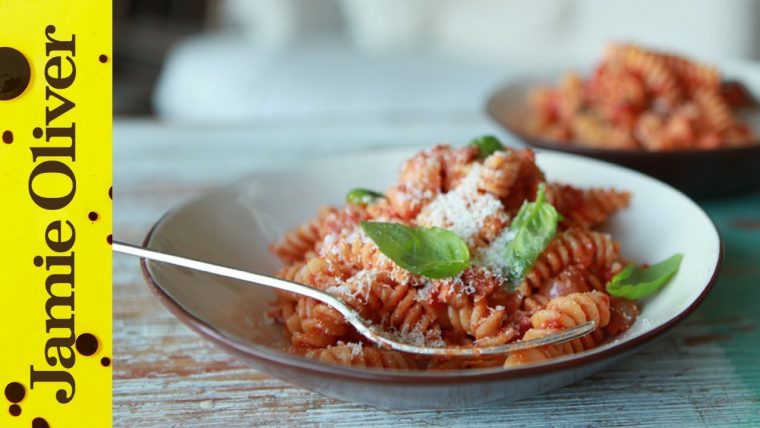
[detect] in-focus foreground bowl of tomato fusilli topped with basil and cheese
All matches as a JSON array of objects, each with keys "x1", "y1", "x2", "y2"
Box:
[{"x1": 142, "y1": 137, "x2": 722, "y2": 409}]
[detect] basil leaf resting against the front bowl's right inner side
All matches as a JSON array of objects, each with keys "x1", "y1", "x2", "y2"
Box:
[{"x1": 607, "y1": 254, "x2": 683, "y2": 300}]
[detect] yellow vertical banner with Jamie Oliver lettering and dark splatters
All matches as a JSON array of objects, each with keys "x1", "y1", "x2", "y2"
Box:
[{"x1": 0, "y1": 0, "x2": 113, "y2": 428}]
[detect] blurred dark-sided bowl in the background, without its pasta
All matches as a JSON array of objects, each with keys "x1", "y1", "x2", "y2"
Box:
[{"x1": 487, "y1": 64, "x2": 760, "y2": 198}]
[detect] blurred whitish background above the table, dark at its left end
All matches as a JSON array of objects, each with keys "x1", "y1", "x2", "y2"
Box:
[{"x1": 115, "y1": 0, "x2": 760, "y2": 120}]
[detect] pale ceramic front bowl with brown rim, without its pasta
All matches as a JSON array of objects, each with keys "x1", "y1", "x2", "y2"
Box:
[{"x1": 143, "y1": 149, "x2": 721, "y2": 409}]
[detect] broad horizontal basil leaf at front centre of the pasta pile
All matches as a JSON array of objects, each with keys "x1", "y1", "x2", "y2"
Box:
[{"x1": 361, "y1": 221, "x2": 470, "y2": 279}]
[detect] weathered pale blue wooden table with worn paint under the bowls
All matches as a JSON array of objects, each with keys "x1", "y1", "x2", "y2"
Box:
[{"x1": 113, "y1": 113, "x2": 760, "y2": 427}]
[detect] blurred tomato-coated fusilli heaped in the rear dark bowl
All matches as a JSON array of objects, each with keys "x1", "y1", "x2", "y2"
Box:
[{"x1": 524, "y1": 44, "x2": 757, "y2": 151}]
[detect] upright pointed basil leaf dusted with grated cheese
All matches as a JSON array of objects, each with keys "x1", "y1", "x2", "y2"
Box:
[{"x1": 505, "y1": 184, "x2": 561, "y2": 286}]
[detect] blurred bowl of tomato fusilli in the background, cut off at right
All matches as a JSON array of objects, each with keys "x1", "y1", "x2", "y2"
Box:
[{"x1": 487, "y1": 44, "x2": 760, "y2": 198}]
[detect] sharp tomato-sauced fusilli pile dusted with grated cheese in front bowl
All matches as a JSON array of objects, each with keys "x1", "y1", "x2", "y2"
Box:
[{"x1": 270, "y1": 143, "x2": 638, "y2": 370}]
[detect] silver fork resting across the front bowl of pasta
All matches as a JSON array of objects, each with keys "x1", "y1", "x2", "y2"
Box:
[{"x1": 113, "y1": 241, "x2": 596, "y2": 357}]
